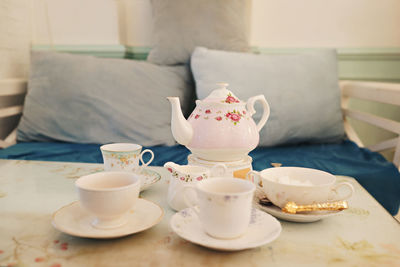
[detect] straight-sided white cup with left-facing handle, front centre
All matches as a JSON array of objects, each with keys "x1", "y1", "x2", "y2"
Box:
[{"x1": 184, "y1": 177, "x2": 256, "y2": 239}]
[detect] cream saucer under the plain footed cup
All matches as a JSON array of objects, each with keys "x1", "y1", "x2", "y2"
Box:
[{"x1": 52, "y1": 198, "x2": 164, "y2": 239}]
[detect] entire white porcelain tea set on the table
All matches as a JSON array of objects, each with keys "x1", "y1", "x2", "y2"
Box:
[{"x1": 52, "y1": 83, "x2": 354, "y2": 251}]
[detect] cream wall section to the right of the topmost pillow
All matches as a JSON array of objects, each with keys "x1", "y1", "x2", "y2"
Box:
[{"x1": 251, "y1": 0, "x2": 400, "y2": 47}]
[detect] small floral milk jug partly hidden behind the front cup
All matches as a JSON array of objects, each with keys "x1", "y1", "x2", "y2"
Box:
[{"x1": 164, "y1": 162, "x2": 228, "y2": 211}]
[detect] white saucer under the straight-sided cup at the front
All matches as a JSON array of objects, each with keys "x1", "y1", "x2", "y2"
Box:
[{"x1": 170, "y1": 208, "x2": 282, "y2": 251}]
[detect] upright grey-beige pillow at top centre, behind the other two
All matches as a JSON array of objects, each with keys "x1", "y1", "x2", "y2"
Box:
[{"x1": 148, "y1": 0, "x2": 251, "y2": 65}]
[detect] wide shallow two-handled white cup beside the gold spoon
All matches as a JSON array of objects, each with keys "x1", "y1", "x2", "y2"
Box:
[{"x1": 247, "y1": 167, "x2": 354, "y2": 208}]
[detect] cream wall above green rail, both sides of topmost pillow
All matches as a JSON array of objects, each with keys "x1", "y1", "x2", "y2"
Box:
[{"x1": 32, "y1": 0, "x2": 400, "y2": 47}]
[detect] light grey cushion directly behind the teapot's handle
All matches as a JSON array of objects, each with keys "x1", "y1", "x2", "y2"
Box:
[{"x1": 191, "y1": 47, "x2": 344, "y2": 146}]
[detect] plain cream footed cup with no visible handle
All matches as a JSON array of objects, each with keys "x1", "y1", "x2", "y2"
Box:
[{"x1": 75, "y1": 172, "x2": 140, "y2": 229}]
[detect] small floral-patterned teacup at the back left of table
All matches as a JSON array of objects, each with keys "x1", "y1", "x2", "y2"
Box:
[{"x1": 100, "y1": 143, "x2": 154, "y2": 172}]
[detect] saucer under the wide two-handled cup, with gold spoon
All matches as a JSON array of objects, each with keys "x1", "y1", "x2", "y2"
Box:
[{"x1": 254, "y1": 194, "x2": 341, "y2": 222}]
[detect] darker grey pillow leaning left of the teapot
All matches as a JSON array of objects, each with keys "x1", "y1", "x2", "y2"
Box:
[{"x1": 18, "y1": 52, "x2": 194, "y2": 146}]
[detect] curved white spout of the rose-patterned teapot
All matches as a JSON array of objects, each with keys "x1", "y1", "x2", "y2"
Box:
[{"x1": 167, "y1": 97, "x2": 193, "y2": 146}]
